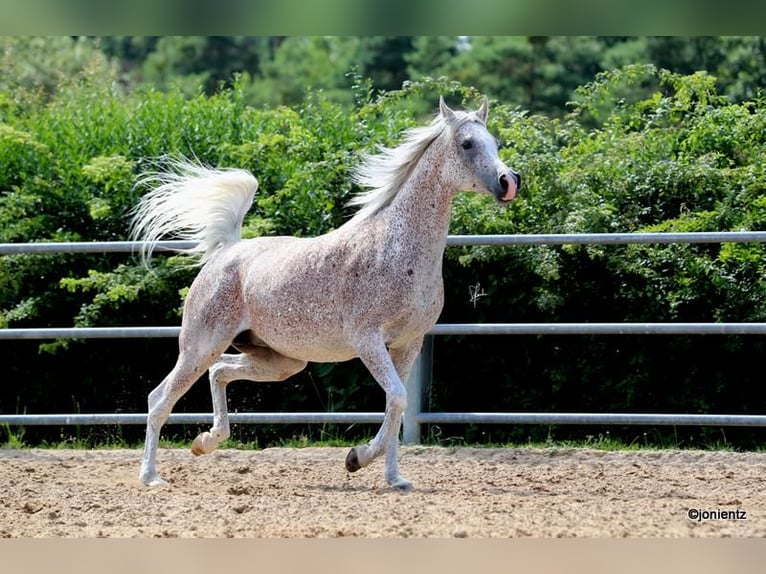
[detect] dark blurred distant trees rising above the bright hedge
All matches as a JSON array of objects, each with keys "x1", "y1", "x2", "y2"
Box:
[{"x1": 90, "y1": 36, "x2": 766, "y2": 117}]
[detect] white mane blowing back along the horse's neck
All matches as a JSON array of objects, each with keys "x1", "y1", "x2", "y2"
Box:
[{"x1": 348, "y1": 112, "x2": 476, "y2": 219}]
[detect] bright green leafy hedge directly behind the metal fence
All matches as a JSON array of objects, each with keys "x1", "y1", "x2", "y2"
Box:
[{"x1": 0, "y1": 44, "x2": 766, "y2": 450}]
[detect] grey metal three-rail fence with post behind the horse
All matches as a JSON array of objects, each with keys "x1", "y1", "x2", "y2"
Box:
[{"x1": 0, "y1": 231, "x2": 766, "y2": 443}]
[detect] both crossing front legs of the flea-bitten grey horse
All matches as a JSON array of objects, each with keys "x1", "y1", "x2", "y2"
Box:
[{"x1": 346, "y1": 337, "x2": 423, "y2": 490}]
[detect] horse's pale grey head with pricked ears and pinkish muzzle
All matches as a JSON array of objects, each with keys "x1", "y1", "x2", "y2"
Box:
[{"x1": 439, "y1": 97, "x2": 521, "y2": 203}]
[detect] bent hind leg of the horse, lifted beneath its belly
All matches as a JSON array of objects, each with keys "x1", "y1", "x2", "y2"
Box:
[{"x1": 191, "y1": 347, "x2": 306, "y2": 455}]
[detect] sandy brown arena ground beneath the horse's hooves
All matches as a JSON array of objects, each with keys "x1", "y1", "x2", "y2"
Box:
[{"x1": 0, "y1": 446, "x2": 766, "y2": 538}]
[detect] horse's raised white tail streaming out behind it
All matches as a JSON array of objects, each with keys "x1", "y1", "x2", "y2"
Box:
[{"x1": 131, "y1": 160, "x2": 258, "y2": 265}]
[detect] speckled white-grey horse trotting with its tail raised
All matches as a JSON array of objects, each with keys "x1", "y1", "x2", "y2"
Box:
[{"x1": 132, "y1": 98, "x2": 521, "y2": 489}]
